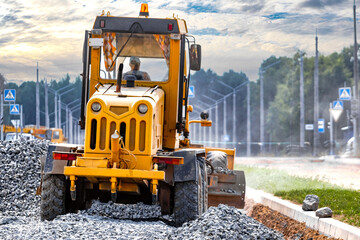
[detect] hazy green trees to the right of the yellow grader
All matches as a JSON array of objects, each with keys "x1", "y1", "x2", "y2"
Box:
[{"x1": 190, "y1": 47, "x2": 354, "y2": 156}]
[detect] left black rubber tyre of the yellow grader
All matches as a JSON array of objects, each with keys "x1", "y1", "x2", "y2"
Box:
[{"x1": 40, "y1": 174, "x2": 66, "y2": 221}]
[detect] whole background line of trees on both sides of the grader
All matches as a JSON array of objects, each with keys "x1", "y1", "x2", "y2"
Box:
[{"x1": 0, "y1": 47, "x2": 354, "y2": 155}]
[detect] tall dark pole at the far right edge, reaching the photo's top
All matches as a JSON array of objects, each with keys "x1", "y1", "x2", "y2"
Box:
[{"x1": 353, "y1": 0, "x2": 359, "y2": 156}]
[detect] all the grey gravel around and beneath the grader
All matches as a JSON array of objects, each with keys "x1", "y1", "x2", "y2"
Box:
[{"x1": 0, "y1": 140, "x2": 283, "y2": 240}]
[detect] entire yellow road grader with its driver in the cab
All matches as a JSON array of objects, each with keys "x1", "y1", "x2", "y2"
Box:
[{"x1": 39, "y1": 4, "x2": 245, "y2": 225}]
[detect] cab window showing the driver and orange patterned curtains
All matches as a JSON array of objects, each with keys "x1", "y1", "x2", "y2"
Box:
[{"x1": 100, "y1": 32, "x2": 170, "y2": 81}]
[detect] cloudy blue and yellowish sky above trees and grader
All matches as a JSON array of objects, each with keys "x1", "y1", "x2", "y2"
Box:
[{"x1": 0, "y1": 0, "x2": 360, "y2": 84}]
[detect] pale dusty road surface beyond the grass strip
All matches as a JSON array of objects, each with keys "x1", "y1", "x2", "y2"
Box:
[{"x1": 235, "y1": 156, "x2": 360, "y2": 190}]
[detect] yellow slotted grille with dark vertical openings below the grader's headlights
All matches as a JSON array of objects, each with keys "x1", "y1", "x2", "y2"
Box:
[{"x1": 89, "y1": 117, "x2": 146, "y2": 152}]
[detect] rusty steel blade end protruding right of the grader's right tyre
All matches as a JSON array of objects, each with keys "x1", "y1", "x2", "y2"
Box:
[{"x1": 208, "y1": 171, "x2": 246, "y2": 208}]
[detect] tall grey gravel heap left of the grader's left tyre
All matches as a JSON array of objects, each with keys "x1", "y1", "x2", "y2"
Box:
[{"x1": 0, "y1": 137, "x2": 48, "y2": 216}]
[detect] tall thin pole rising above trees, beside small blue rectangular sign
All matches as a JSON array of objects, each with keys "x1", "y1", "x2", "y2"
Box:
[{"x1": 313, "y1": 31, "x2": 319, "y2": 156}]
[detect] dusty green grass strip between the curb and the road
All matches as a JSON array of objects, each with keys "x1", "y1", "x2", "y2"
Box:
[{"x1": 235, "y1": 165, "x2": 360, "y2": 227}]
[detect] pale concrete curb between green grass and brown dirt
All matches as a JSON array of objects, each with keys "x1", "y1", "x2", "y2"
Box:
[{"x1": 246, "y1": 187, "x2": 360, "y2": 240}]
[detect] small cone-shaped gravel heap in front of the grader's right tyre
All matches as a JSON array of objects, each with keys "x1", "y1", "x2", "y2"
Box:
[{"x1": 167, "y1": 204, "x2": 284, "y2": 240}]
